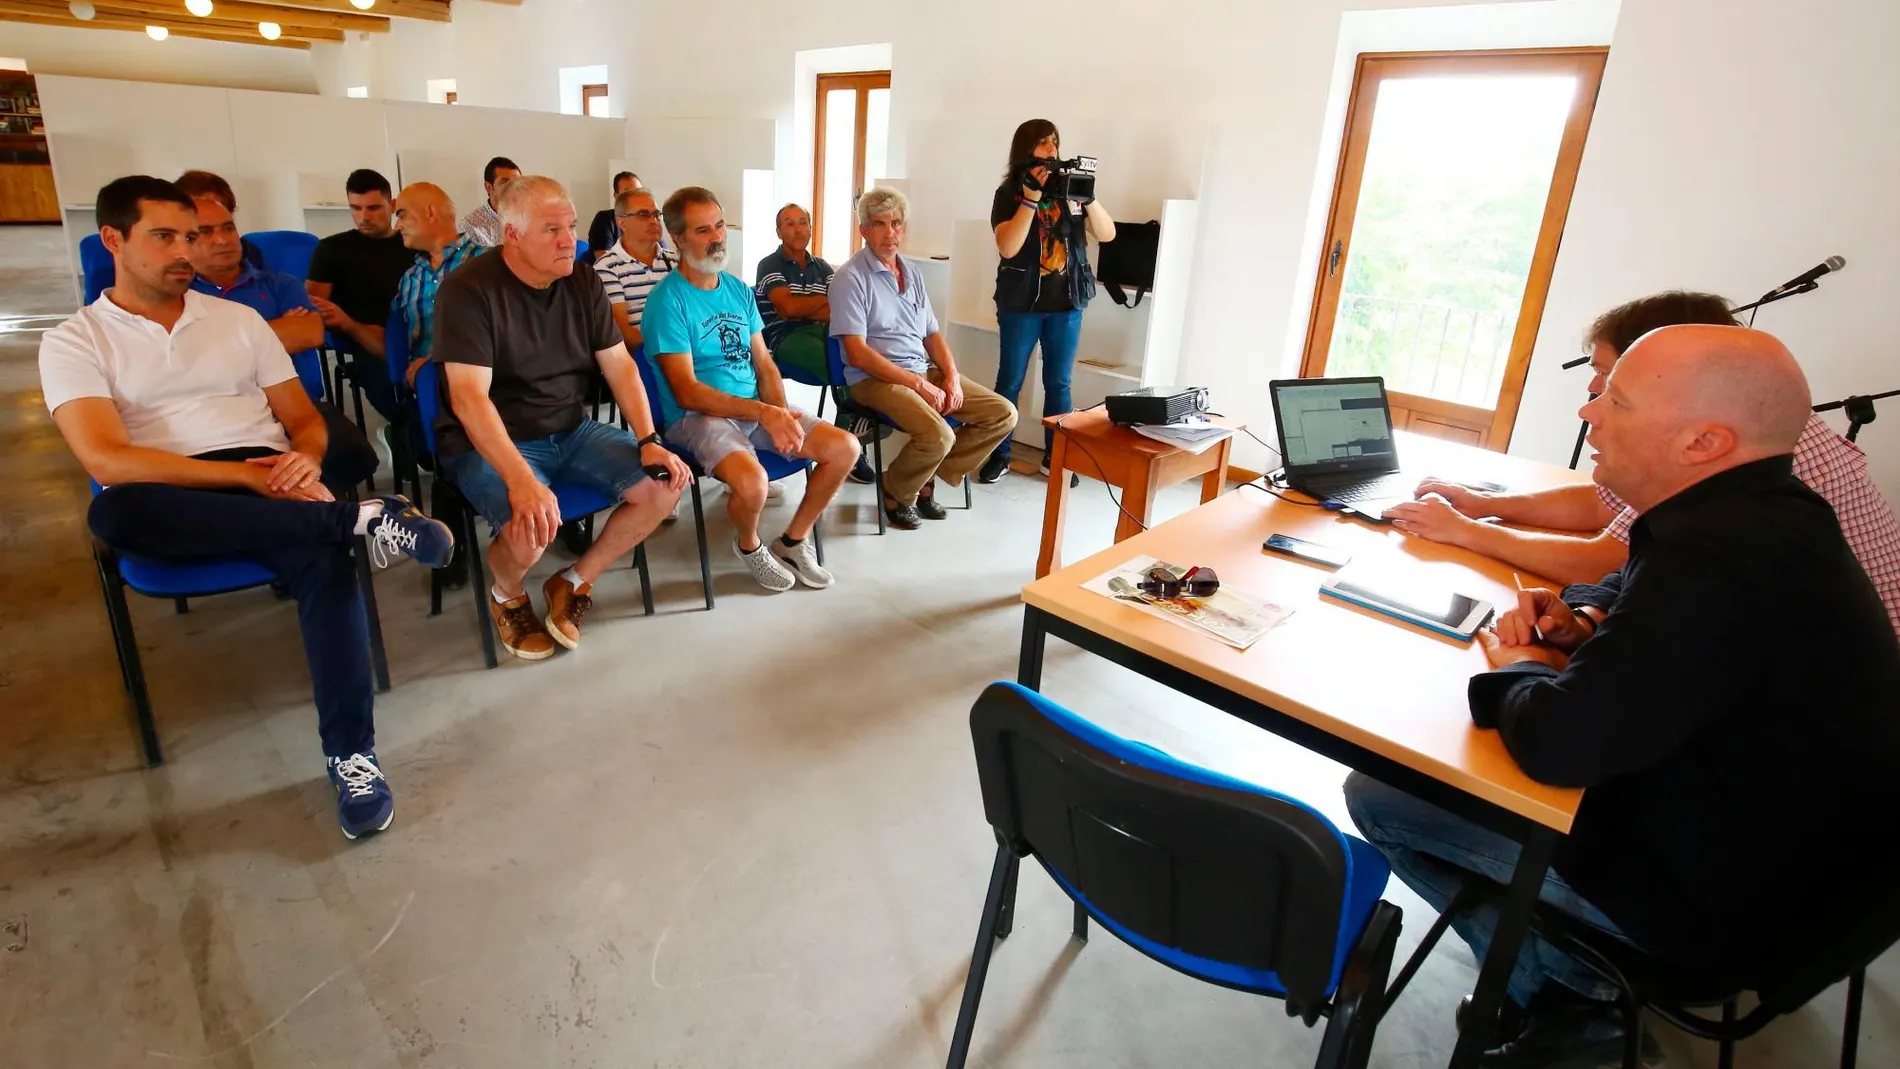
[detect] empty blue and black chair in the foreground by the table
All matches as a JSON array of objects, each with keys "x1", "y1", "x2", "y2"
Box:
[{"x1": 948, "y1": 684, "x2": 1400, "y2": 1069}]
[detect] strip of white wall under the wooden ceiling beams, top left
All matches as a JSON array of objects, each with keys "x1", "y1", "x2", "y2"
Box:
[{"x1": 0, "y1": 21, "x2": 315, "y2": 95}]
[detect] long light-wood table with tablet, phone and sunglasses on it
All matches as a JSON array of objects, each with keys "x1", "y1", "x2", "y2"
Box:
[{"x1": 1018, "y1": 435, "x2": 1583, "y2": 1067}]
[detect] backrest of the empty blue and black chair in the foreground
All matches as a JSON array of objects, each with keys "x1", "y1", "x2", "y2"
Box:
[{"x1": 969, "y1": 684, "x2": 1353, "y2": 1018}]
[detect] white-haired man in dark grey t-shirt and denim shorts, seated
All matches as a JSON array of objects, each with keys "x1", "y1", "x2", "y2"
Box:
[{"x1": 433, "y1": 175, "x2": 692, "y2": 661}]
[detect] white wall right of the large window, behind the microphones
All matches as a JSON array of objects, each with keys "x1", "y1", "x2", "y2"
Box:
[{"x1": 1511, "y1": 0, "x2": 1900, "y2": 501}]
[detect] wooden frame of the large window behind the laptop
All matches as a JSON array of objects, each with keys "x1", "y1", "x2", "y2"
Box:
[{"x1": 1300, "y1": 47, "x2": 1609, "y2": 450}]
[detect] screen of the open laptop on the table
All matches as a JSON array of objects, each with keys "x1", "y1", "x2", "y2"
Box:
[{"x1": 1271, "y1": 378, "x2": 1398, "y2": 475}]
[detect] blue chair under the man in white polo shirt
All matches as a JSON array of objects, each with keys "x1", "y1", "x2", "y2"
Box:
[{"x1": 91, "y1": 482, "x2": 390, "y2": 767}]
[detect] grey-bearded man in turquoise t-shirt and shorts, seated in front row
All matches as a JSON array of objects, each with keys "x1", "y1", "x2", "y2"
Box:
[{"x1": 640, "y1": 186, "x2": 859, "y2": 591}]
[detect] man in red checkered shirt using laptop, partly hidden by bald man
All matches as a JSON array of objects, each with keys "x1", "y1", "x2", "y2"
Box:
[{"x1": 1385, "y1": 291, "x2": 1900, "y2": 632}]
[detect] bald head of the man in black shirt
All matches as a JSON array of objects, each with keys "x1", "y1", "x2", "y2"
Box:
[{"x1": 1583, "y1": 325, "x2": 1809, "y2": 511}]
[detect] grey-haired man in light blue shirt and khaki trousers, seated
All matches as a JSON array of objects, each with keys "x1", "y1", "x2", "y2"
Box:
[{"x1": 828, "y1": 190, "x2": 1017, "y2": 530}]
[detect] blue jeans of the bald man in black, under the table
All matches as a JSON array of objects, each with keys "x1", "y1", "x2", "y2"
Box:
[{"x1": 1345, "y1": 773, "x2": 1623, "y2": 1006}]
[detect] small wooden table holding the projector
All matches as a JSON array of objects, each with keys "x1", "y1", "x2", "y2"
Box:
[{"x1": 1036, "y1": 408, "x2": 1246, "y2": 579}]
